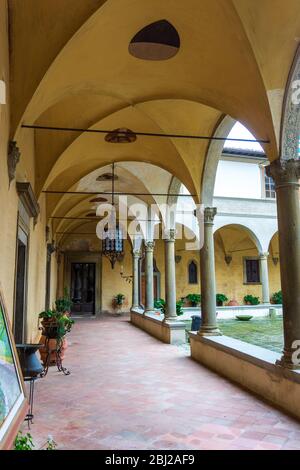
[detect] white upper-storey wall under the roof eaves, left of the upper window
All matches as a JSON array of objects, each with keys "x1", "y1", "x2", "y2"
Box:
[{"x1": 214, "y1": 160, "x2": 262, "y2": 199}]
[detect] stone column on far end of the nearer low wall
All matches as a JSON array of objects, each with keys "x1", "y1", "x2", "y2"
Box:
[{"x1": 198, "y1": 207, "x2": 221, "y2": 336}]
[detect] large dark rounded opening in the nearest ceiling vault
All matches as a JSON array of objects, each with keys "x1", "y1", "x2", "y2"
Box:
[{"x1": 129, "y1": 20, "x2": 180, "y2": 60}]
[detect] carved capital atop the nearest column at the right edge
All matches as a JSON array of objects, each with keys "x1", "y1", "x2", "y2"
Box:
[{"x1": 266, "y1": 159, "x2": 300, "y2": 189}]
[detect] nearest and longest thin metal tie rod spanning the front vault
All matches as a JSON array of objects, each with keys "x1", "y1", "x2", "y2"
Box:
[{"x1": 21, "y1": 124, "x2": 270, "y2": 144}]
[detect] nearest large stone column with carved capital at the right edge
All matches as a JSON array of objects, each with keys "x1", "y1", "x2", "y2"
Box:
[{"x1": 267, "y1": 160, "x2": 300, "y2": 369}]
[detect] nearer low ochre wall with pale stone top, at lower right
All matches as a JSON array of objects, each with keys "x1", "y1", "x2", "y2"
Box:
[{"x1": 190, "y1": 333, "x2": 300, "y2": 419}]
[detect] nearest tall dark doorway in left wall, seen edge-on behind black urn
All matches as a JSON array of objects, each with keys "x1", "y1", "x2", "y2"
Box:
[{"x1": 14, "y1": 227, "x2": 28, "y2": 343}]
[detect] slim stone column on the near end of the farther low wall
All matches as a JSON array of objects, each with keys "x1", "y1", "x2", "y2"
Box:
[{"x1": 165, "y1": 229, "x2": 177, "y2": 321}]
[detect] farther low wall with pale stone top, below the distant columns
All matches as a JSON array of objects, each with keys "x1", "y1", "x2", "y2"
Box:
[{"x1": 130, "y1": 309, "x2": 186, "y2": 344}]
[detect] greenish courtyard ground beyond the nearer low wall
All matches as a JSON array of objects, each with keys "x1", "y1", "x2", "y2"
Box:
[{"x1": 187, "y1": 316, "x2": 283, "y2": 352}]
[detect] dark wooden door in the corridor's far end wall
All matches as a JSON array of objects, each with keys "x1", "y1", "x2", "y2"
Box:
[{"x1": 71, "y1": 263, "x2": 96, "y2": 315}]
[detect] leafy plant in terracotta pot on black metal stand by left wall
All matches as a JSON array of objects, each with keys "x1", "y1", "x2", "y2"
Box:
[{"x1": 39, "y1": 310, "x2": 74, "y2": 366}]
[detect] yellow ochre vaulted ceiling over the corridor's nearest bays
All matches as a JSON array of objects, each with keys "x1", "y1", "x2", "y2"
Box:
[{"x1": 9, "y1": 0, "x2": 300, "y2": 226}]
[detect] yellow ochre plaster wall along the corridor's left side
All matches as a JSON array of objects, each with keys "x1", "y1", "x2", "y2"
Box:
[{"x1": 0, "y1": 0, "x2": 57, "y2": 342}]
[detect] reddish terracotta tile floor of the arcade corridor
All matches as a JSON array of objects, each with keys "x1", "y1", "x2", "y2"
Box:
[{"x1": 24, "y1": 317, "x2": 300, "y2": 450}]
